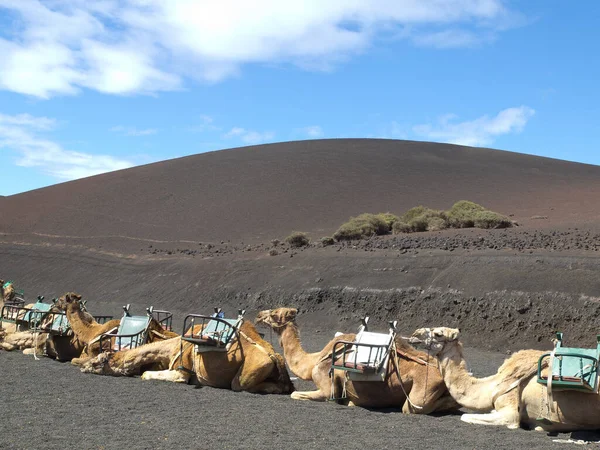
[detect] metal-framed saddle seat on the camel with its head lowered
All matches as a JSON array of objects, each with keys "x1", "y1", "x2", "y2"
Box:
[{"x1": 181, "y1": 308, "x2": 246, "y2": 352}]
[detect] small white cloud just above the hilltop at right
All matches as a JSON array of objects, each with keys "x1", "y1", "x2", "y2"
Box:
[{"x1": 413, "y1": 106, "x2": 535, "y2": 146}]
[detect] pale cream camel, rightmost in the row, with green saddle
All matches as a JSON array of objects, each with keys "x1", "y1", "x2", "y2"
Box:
[{"x1": 411, "y1": 327, "x2": 600, "y2": 432}]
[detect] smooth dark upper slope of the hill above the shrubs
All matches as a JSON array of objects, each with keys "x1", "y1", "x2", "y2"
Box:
[{"x1": 0, "y1": 139, "x2": 600, "y2": 241}]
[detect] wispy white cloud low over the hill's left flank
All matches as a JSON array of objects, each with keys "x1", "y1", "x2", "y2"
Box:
[{"x1": 0, "y1": 114, "x2": 133, "y2": 180}]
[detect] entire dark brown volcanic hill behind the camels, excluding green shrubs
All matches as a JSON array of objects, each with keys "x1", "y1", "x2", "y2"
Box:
[{"x1": 0, "y1": 139, "x2": 600, "y2": 349}]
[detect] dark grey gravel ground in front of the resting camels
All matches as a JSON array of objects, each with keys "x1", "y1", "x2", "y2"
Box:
[{"x1": 0, "y1": 336, "x2": 596, "y2": 450}]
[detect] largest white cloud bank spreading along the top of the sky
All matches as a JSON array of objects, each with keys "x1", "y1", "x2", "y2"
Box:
[{"x1": 0, "y1": 0, "x2": 516, "y2": 98}]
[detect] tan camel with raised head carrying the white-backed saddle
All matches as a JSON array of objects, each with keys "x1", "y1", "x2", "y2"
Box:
[{"x1": 256, "y1": 308, "x2": 458, "y2": 414}]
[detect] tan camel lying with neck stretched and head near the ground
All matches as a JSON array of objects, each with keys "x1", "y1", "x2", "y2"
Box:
[{"x1": 82, "y1": 322, "x2": 294, "y2": 394}]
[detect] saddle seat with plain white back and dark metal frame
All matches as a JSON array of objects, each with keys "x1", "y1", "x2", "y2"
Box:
[{"x1": 329, "y1": 317, "x2": 398, "y2": 400}]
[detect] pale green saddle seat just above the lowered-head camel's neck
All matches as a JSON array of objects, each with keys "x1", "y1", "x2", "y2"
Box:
[{"x1": 100, "y1": 304, "x2": 153, "y2": 352}]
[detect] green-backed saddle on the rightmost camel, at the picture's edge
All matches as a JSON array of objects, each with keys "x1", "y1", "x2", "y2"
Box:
[{"x1": 537, "y1": 332, "x2": 600, "y2": 394}]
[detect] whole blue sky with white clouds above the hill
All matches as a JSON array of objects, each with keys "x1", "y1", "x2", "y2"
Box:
[{"x1": 0, "y1": 0, "x2": 600, "y2": 195}]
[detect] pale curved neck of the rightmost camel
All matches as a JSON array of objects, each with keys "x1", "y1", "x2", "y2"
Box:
[{"x1": 438, "y1": 341, "x2": 496, "y2": 411}]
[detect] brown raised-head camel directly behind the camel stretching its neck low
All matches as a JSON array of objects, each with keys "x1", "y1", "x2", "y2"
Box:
[{"x1": 56, "y1": 292, "x2": 178, "y2": 365}]
